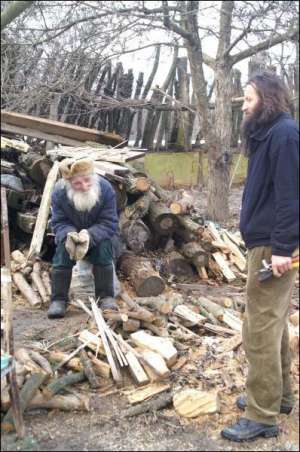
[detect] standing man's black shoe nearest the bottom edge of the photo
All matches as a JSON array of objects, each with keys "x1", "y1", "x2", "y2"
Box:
[{"x1": 221, "y1": 417, "x2": 279, "y2": 442}]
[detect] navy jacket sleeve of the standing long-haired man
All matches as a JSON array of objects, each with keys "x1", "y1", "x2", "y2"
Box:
[{"x1": 271, "y1": 137, "x2": 299, "y2": 256}]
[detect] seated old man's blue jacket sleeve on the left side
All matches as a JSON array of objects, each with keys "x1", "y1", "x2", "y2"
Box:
[{"x1": 51, "y1": 191, "x2": 77, "y2": 243}]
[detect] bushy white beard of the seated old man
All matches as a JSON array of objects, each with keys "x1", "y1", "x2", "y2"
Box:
[{"x1": 65, "y1": 176, "x2": 101, "y2": 212}]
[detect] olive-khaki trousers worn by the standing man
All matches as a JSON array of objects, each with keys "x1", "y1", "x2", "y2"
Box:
[{"x1": 243, "y1": 246, "x2": 296, "y2": 425}]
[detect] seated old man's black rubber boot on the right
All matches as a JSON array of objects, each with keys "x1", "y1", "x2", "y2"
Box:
[{"x1": 93, "y1": 265, "x2": 118, "y2": 311}]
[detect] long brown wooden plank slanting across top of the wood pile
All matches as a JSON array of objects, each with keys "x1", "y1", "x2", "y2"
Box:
[{"x1": 1, "y1": 110, "x2": 123, "y2": 145}]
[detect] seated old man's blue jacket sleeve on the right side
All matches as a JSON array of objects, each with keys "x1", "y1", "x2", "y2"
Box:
[{"x1": 88, "y1": 183, "x2": 119, "y2": 247}]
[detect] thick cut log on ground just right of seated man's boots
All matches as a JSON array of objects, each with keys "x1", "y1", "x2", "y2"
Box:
[{"x1": 120, "y1": 255, "x2": 165, "y2": 297}]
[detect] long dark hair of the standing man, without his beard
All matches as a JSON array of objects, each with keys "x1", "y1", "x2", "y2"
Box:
[{"x1": 247, "y1": 72, "x2": 294, "y2": 124}]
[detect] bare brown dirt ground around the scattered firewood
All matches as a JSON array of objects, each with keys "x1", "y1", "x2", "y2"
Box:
[{"x1": 1, "y1": 188, "x2": 299, "y2": 451}]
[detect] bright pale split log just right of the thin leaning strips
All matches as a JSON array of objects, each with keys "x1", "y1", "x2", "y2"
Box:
[{"x1": 130, "y1": 330, "x2": 177, "y2": 366}]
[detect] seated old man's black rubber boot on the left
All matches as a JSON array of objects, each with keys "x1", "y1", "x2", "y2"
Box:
[{"x1": 48, "y1": 267, "x2": 72, "y2": 319}]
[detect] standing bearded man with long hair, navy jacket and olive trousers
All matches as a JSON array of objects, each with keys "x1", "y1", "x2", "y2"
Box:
[{"x1": 222, "y1": 72, "x2": 299, "y2": 441}]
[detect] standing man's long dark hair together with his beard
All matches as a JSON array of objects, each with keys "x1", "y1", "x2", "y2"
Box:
[{"x1": 241, "y1": 72, "x2": 294, "y2": 156}]
